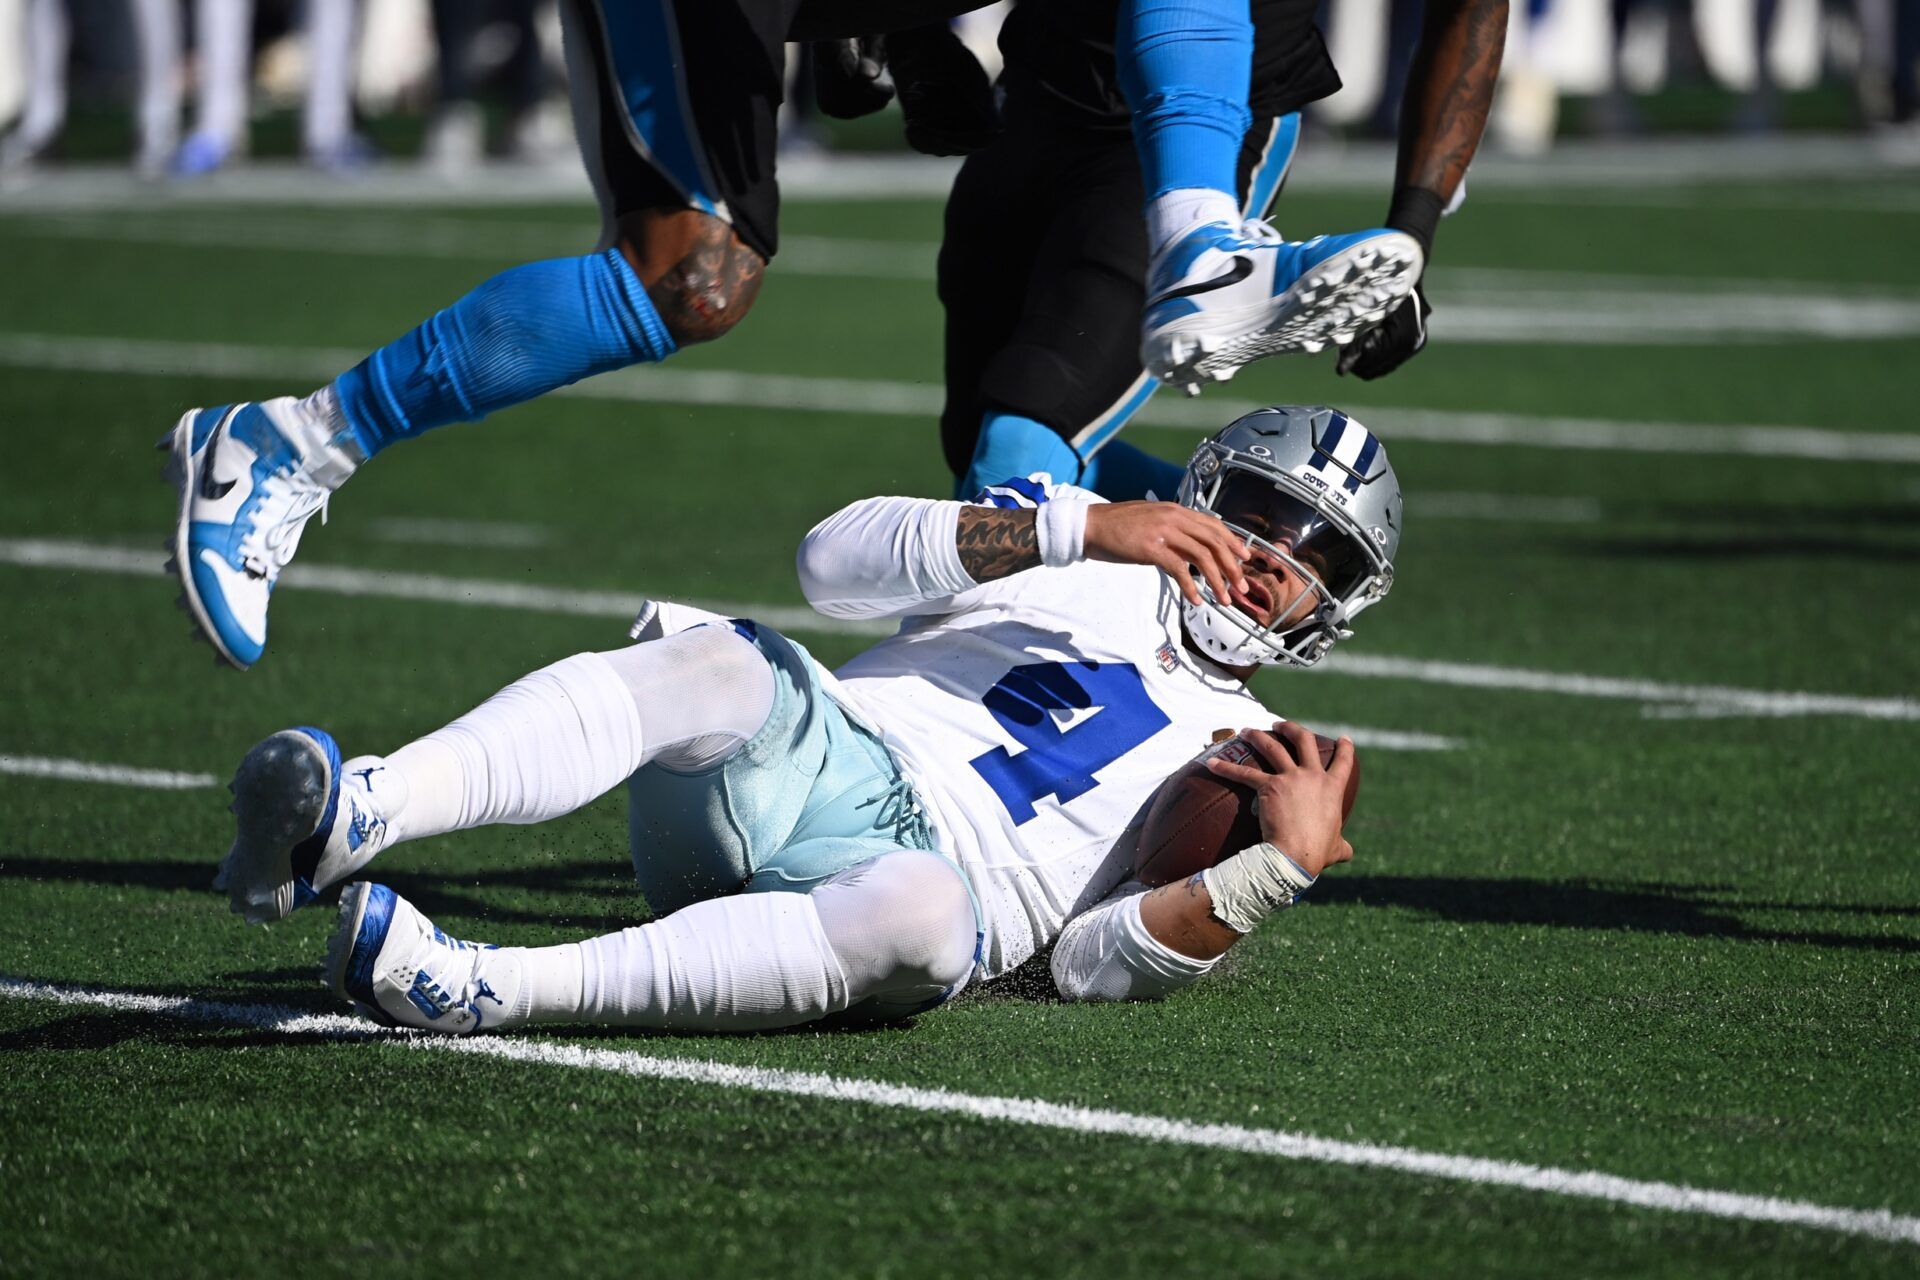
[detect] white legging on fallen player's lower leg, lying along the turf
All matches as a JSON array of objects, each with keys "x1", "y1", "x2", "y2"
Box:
[{"x1": 513, "y1": 850, "x2": 977, "y2": 1031}]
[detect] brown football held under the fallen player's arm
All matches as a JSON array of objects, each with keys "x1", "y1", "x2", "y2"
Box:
[{"x1": 1133, "y1": 733, "x2": 1359, "y2": 885}]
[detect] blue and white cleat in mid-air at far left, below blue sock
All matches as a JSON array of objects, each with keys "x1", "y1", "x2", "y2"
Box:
[{"x1": 157, "y1": 397, "x2": 332, "y2": 670}]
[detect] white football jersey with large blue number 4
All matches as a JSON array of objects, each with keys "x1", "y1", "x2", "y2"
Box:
[{"x1": 810, "y1": 476, "x2": 1275, "y2": 979}]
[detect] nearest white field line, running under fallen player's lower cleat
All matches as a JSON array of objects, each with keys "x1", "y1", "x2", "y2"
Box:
[{"x1": 0, "y1": 979, "x2": 1920, "y2": 1244}]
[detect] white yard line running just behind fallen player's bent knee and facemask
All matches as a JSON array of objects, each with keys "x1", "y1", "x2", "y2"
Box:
[{"x1": 0, "y1": 537, "x2": 1920, "y2": 725}]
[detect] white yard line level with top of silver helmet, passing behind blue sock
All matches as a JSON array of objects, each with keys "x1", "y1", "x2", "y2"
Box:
[{"x1": 0, "y1": 332, "x2": 1920, "y2": 462}]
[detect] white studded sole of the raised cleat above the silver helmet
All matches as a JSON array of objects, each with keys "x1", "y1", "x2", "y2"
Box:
[{"x1": 1142, "y1": 232, "x2": 1423, "y2": 395}]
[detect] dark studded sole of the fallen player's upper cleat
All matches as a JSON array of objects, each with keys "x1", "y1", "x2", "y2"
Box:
[{"x1": 221, "y1": 729, "x2": 334, "y2": 925}]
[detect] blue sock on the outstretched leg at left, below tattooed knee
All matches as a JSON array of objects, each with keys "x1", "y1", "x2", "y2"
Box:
[{"x1": 334, "y1": 249, "x2": 676, "y2": 459}]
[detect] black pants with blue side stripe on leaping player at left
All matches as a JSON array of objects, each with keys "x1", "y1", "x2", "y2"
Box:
[{"x1": 561, "y1": 0, "x2": 983, "y2": 257}]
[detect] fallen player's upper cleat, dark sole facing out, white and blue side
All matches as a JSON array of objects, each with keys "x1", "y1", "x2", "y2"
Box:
[{"x1": 213, "y1": 725, "x2": 405, "y2": 925}]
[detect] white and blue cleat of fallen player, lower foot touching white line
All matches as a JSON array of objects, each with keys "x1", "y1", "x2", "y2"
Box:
[{"x1": 324, "y1": 883, "x2": 524, "y2": 1036}]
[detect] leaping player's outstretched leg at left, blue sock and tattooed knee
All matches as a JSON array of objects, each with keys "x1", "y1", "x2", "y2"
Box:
[{"x1": 161, "y1": 0, "x2": 778, "y2": 668}]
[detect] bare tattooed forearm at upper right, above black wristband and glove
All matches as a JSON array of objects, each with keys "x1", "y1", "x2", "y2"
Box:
[{"x1": 1396, "y1": 0, "x2": 1507, "y2": 200}]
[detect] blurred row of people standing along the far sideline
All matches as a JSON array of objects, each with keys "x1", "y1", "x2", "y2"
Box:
[{"x1": 0, "y1": 0, "x2": 1920, "y2": 180}]
